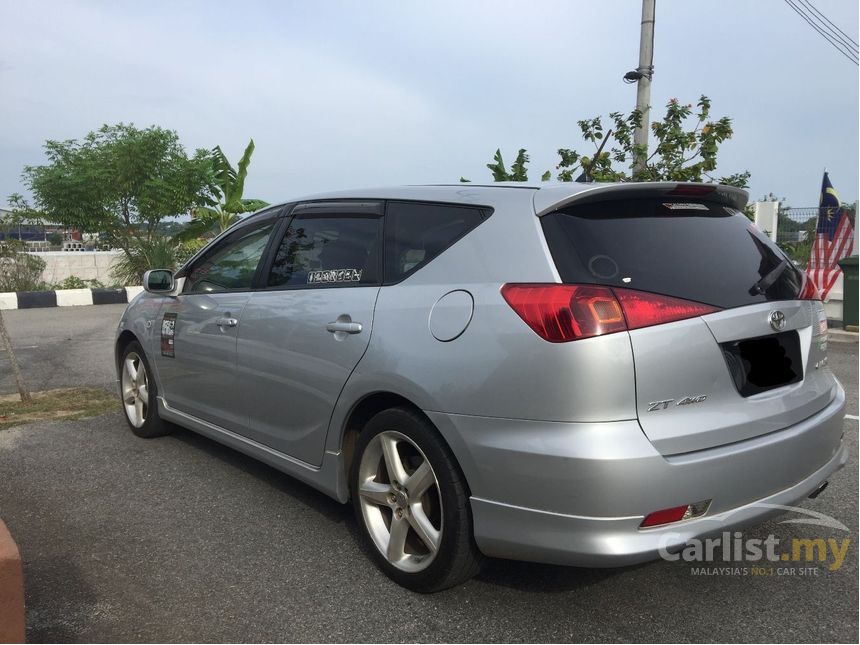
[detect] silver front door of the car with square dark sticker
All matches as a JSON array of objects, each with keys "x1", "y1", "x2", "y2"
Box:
[{"x1": 156, "y1": 210, "x2": 278, "y2": 432}]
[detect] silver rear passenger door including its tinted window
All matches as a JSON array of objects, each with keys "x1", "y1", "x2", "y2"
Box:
[{"x1": 238, "y1": 202, "x2": 382, "y2": 465}]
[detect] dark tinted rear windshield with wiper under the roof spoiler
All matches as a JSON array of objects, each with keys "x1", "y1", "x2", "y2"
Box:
[{"x1": 542, "y1": 199, "x2": 803, "y2": 308}]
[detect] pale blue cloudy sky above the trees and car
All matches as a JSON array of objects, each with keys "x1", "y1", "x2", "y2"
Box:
[{"x1": 0, "y1": 0, "x2": 858, "y2": 207}]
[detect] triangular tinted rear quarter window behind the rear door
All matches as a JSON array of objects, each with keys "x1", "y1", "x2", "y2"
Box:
[{"x1": 385, "y1": 202, "x2": 486, "y2": 282}]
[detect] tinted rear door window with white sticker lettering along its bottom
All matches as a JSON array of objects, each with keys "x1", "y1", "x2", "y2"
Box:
[{"x1": 266, "y1": 215, "x2": 381, "y2": 287}]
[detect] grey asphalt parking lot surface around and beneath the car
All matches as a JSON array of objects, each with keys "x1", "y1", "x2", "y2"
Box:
[{"x1": 0, "y1": 306, "x2": 858, "y2": 642}]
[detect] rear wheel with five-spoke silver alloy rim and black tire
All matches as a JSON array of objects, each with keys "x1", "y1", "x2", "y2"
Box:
[{"x1": 350, "y1": 408, "x2": 481, "y2": 593}]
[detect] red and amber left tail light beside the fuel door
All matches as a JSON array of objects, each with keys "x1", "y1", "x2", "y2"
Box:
[{"x1": 502, "y1": 284, "x2": 718, "y2": 343}]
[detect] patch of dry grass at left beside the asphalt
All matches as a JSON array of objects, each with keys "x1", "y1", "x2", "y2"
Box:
[{"x1": 0, "y1": 387, "x2": 119, "y2": 430}]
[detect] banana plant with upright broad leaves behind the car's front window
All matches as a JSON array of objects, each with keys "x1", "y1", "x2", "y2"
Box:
[{"x1": 179, "y1": 139, "x2": 268, "y2": 240}]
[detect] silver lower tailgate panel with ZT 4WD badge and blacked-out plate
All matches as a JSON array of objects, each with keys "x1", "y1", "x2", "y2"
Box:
[{"x1": 630, "y1": 301, "x2": 835, "y2": 454}]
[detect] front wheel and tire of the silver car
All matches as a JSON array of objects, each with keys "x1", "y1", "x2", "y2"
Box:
[{"x1": 119, "y1": 341, "x2": 170, "y2": 439}]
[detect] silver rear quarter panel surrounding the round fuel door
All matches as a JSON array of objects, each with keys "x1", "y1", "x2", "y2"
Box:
[{"x1": 327, "y1": 197, "x2": 636, "y2": 450}]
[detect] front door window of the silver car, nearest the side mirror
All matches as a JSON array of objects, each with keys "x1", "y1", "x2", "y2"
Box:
[{"x1": 182, "y1": 219, "x2": 276, "y2": 293}]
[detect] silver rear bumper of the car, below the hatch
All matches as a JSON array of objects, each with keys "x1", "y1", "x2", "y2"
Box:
[{"x1": 428, "y1": 387, "x2": 848, "y2": 566}]
